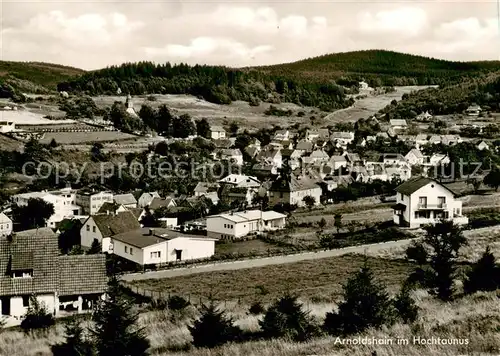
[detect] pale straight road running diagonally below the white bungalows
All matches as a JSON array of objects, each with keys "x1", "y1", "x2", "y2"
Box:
[{"x1": 122, "y1": 239, "x2": 412, "y2": 282}]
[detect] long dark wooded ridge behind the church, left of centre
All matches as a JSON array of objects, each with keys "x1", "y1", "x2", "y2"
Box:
[{"x1": 58, "y1": 62, "x2": 352, "y2": 111}]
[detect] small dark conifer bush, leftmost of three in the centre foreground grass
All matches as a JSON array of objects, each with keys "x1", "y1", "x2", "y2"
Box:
[{"x1": 188, "y1": 302, "x2": 242, "y2": 348}]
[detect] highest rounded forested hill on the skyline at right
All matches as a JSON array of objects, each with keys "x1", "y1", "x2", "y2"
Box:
[{"x1": 256, "y1": 50, "x2": 500, "y2": 86}]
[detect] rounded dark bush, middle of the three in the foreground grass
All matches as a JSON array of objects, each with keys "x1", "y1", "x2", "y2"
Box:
[{"x1": 259, "y1": 295, "x2": 318, "y2": 341}]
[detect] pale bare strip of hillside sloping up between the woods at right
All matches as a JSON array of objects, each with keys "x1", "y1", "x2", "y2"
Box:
[{"x1": 323, "y1": 86, "x2": 428, "y2": 124}]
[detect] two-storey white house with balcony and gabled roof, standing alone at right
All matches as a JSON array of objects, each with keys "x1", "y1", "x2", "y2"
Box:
[{"x1": 393, "y1": 177, "x2": 469, "y2": 228}]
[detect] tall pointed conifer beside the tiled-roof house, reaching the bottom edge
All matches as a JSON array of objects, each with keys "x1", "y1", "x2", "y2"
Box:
[{"x1": 91, "y1": 276, "x2": 149, "y2": 356}]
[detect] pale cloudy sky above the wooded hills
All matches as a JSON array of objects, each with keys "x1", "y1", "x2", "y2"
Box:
[{"x1": 0, "y1": 0, "x2": 500, "y2": 70}]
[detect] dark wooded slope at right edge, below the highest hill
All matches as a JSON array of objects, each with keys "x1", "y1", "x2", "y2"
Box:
[{"x1": 381, "y1": 72, "x2": 500, "y2": 119}]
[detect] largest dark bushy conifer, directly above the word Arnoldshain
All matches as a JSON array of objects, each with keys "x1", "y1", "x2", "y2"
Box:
[{"x1": 323, "y1": 265, "x2": 396, "y2": 335}]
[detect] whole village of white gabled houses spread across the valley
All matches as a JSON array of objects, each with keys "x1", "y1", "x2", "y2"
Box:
[{"x1": 0, "y1": 84, "x2": 500, "y2": 325}]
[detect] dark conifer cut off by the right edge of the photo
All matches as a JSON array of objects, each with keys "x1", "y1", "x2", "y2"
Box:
[{"x1": 464, "y1": 246, "x2": 500, "y2": 294}]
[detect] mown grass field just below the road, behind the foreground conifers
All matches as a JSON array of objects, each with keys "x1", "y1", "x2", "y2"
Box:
[{"x1": 127, "y1": 255, "x2": 411, "y2": 303}]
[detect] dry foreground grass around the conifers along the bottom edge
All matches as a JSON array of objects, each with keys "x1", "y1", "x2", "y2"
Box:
[{"x1": 0, "y1": 291, "x2": 500, "y2": 356}]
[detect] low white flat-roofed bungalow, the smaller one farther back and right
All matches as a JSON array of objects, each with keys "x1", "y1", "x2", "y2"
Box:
[{"x1": 207, "y1": 210, "x2": 286, "y2": 240}]
